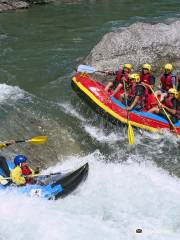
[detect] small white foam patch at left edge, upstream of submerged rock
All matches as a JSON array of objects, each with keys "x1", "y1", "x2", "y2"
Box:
[{"x1": 0, "y1": 83, "x2": 24, "y2": 103}]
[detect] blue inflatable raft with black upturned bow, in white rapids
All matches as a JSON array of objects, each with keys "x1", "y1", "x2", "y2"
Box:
[{"x1": 0, "y1": 161, "x2": 89, "y2": 200}]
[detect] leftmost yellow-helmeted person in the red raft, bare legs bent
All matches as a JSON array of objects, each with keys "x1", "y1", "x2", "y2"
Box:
[{"x1": 105, "y1": 63, "x2": 133, "y2": 96}]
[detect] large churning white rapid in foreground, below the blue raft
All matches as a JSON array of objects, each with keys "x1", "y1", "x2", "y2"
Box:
[{"x1": 0, "y1": 153, "x2": 180, "y2": 240}]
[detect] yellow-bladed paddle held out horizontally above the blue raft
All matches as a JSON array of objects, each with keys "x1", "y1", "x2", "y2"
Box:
[{"x1": 0, "y1": 136, "x2": 48, "y2": 148}]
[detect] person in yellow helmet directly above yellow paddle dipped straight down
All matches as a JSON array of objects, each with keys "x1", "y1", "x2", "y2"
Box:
[{"x1": 124, "y1": 73, "x2": 148, "y2": 111}]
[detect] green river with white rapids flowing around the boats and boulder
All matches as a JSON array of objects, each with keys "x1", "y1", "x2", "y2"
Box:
[{"x1": 0, "y1": 0, "x2": 180, "y2": 240}]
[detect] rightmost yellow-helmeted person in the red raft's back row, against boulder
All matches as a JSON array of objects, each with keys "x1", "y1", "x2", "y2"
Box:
[{"x1": 156, "y1": 63, "x2": 176, "y2": 101}]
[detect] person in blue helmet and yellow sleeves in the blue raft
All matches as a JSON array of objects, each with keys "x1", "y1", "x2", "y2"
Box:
[{"x1": 11, "y1": 155, "x2": 37, "y2": 186}]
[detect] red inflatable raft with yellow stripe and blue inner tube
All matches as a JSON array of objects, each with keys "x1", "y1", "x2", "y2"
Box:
[{"x1": 71, "y1": 73, "x2": 180, "y2": 136}]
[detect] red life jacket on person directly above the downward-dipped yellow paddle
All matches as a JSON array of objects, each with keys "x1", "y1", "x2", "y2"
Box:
[{"x1": 129, "y1": 83, "x2": 148, "y2": 110}]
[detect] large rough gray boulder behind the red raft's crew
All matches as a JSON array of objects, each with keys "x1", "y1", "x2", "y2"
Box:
[{"x1": 85, "y1": 21, "x2": 180, "y2": 70}]
